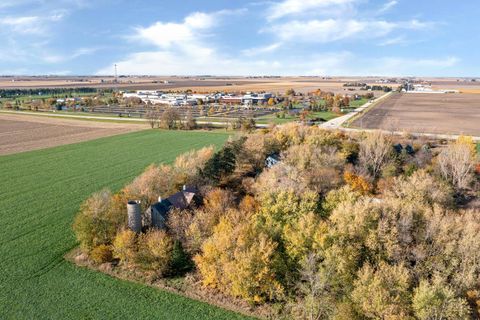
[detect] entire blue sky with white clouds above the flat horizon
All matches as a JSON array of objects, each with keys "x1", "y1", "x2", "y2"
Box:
[{"x1": 0, "y1": 0, "x2": 480, "y2": 76}]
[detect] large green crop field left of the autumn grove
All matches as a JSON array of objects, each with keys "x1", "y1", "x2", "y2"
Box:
[{"x1": 0, "y1": 131, "x2": 251, "y2": 319}]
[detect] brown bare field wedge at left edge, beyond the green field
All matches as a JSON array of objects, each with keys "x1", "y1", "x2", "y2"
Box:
[{"x1": 0, "y1": 113, "x2": 147, "y2": 155}]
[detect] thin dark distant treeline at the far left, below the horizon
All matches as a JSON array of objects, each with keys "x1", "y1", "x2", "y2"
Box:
[{"x1": 0, "y1": 87, "x2": 107, "y2": 98}]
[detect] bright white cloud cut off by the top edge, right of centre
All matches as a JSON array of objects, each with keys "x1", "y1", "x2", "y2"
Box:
[{"x1": 267, "y1": 0, "x2": 357, "y2": 20}]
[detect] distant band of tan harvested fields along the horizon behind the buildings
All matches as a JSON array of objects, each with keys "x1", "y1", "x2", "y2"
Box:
[{"x1": 0, "y1": 76, "x2": 390, "y2": 95}]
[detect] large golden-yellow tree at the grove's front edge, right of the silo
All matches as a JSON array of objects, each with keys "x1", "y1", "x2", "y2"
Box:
[{"x1": 194, "y1": 212, "x2": 283, "y2": 303}]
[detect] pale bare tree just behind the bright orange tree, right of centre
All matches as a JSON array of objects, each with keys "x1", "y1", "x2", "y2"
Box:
[{"x1": 359, "y1": 131, "x2": 392, "y2": 178}]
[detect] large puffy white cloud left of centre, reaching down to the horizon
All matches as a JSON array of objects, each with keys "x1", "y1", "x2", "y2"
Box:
[{"x1": 98, "y1": 11, "x2": 352, "y2": 75}]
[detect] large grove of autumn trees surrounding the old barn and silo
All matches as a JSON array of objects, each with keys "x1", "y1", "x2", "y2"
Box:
[{"x1": 74, "y1": 124, "x2": 480, "y2": 320}]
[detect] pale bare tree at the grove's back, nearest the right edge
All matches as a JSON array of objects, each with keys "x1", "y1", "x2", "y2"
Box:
[{"x1": 437, "y1": 142, "x2": 474, "y2": 191}]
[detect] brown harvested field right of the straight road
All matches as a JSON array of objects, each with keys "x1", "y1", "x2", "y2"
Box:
[{"x1": 353, "y1": 94, "x2": 480, "y2": 136}]
